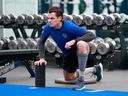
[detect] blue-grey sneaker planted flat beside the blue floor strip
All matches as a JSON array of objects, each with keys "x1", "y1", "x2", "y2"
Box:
[{"x1": 73, "y1": 78, "x2": 85, "y2": 90}]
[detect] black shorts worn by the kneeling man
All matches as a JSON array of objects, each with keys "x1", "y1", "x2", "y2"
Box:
[{"x1": 63, "y1": 49, "x2": 78, "y2": 73}]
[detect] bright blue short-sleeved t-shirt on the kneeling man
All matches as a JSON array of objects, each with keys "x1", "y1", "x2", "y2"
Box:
[{"x1": 41, "y1": 20, "x2": 86, "y2": 56}]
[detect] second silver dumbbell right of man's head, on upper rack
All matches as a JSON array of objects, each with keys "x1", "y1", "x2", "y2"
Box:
[{"x1": 72, "y1": 14, "x2": 84, "y2": 26}]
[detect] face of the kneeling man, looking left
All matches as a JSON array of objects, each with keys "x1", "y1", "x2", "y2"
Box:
[{"x1": 48, "y1": 12, "x2": 61, "y2": 28}]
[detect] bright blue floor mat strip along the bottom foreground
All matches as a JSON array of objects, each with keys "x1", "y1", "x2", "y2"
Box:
[{"x1": 0, "y1": 84, "x2": 128, "y2": 96}]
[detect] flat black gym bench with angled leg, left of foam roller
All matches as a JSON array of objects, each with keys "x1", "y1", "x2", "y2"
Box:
[{"x1": 0, "y1": 49, "x2": 38, "y2": 77}]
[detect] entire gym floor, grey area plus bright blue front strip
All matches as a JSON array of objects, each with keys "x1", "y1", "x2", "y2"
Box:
[{"x1": 0, "y1": 65, "x2": 128, "y2": 96}]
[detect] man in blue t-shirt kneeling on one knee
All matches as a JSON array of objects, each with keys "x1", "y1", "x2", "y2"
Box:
[{"x1": 35, "y1": 7, "x2": 102, "y2": 90}]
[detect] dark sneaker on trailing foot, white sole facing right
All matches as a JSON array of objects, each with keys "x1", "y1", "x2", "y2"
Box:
[{"x1": 93, "y1": 63, "x2": 103, "y2": 81}]
